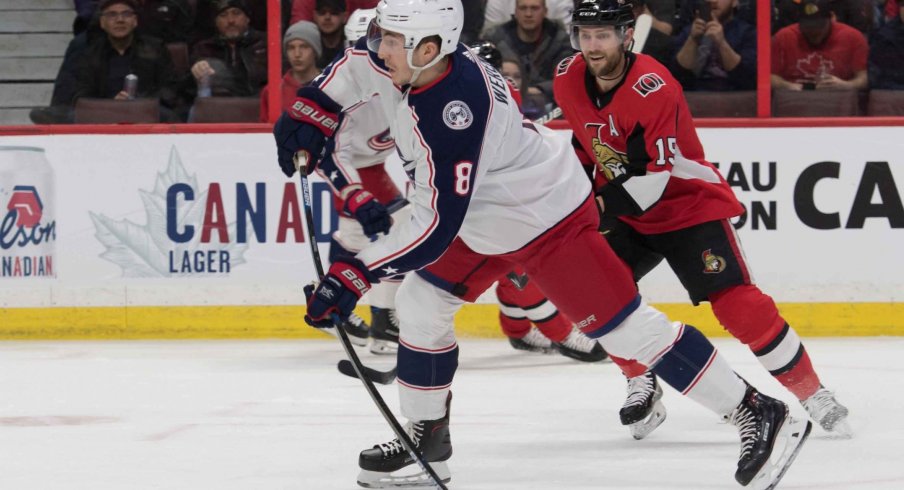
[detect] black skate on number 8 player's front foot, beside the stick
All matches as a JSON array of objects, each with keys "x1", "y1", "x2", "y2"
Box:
[{"x1": 358, "y1": 393, "x2": 452, "y2": 488}]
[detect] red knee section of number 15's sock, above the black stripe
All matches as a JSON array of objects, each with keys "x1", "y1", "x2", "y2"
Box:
[{"x1": 709, "y1": 284, "x2": 785, "y2": 349}]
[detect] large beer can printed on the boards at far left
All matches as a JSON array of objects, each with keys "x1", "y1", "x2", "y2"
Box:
[{"x1": 0, "y1": 145, "x2": 57, "y2": 280}]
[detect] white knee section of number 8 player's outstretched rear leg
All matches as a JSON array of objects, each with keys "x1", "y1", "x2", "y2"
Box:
[{"x1": 599, "y1": 300, "x2": 681, "y2": 366}]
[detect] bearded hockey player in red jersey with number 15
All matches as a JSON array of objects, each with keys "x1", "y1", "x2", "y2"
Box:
[{"x1": 554, "y1": 0, "x2": 850, "y2": 435}]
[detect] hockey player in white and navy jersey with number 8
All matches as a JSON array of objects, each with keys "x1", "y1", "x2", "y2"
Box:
[{"x1": 274, "y1": 0, "x2": 810, "y2": 488}]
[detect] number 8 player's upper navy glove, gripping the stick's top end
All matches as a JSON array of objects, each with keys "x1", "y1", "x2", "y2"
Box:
[{"x1": 273, "y1": 87, "x2": 342, "y2": 177}]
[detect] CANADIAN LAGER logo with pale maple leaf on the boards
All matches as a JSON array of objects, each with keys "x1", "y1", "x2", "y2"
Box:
[{"x1": 91, "y1": 148, "x2": 335, "y2": 277}]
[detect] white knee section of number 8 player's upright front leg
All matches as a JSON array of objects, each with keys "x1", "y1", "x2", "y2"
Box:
[{"x1": 396, "y1": 274, "x2": 464, "y2": 350}]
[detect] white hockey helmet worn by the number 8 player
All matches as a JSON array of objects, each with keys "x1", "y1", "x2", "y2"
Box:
[{"x1": 367, "y1": 0, "x2": 465, "y2": 70}]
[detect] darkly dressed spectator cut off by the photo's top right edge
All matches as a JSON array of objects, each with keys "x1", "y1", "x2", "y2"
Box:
[{"x1": 869, "y1": 0, "x2": 904, "y2": 90}]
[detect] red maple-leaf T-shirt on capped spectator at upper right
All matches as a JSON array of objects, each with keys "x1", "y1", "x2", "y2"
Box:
[{"x1": 772, "y1": 21, "x2": 869, "y2": 82}]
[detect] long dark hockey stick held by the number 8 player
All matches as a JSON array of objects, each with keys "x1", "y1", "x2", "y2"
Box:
[{"x1": 295, "y1": 152, "x2": 448, "y2": 490}]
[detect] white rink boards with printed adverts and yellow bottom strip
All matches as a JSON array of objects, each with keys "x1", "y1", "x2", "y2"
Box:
[{"x1": 0, "y1": 127, "x2": 904, "y2": 339}]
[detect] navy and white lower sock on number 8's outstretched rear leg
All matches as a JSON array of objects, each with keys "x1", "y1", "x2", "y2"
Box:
[{"x1": 653, "y1": 325, "x2": 747, "y2": 416}]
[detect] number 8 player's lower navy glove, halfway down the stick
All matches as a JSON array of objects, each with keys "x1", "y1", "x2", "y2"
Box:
[{"x1": 304, "y1": 257, "x2": 379, "y2": 328}]
